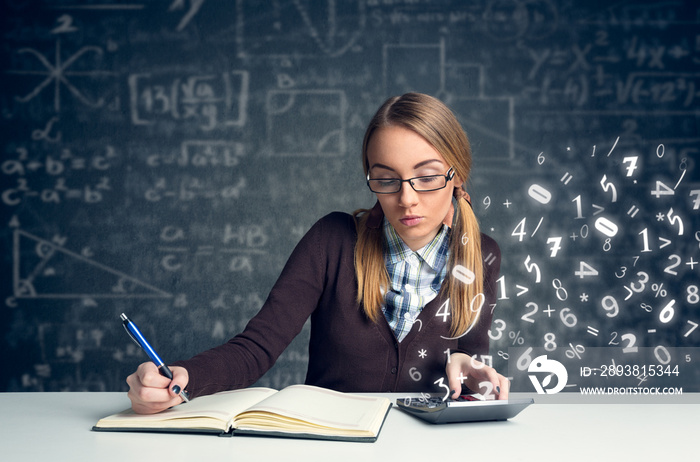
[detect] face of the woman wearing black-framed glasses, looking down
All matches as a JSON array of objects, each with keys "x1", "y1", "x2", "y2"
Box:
[{"x1": 367, "y1": 126, "x2": 462, "y2": 251}]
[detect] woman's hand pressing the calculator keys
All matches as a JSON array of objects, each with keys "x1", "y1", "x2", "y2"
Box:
[{"x1": 445, "y1": 353, "x2": 510, "y2": 399}]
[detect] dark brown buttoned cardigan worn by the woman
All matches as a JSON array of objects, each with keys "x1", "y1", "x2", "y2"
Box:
[{"x1": 174, "y1": 212, "x2": 501, "y2": 396}]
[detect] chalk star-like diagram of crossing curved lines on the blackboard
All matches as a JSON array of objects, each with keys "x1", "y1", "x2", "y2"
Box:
[{"x1": 6, "y1": 40, "x2": 114, "y2": 112}]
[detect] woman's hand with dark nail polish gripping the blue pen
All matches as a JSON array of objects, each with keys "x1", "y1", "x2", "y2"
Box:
[{"x1": 126, "y1": 362, "x2": 190, "y2": 414}]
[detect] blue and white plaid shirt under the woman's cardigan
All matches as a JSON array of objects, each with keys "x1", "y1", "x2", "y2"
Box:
[{"x1": 382, "y1": 218, "x2": 449, "y2": 342}]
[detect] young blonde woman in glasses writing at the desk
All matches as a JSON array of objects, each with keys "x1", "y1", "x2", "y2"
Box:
[{"x1": 127, "y1": 93, "x2": 509, "y2": 413}]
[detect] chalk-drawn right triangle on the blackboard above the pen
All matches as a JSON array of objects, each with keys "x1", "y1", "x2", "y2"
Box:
[{"x1": 12, "y1": 228, "x2": 172, "y2": 299}]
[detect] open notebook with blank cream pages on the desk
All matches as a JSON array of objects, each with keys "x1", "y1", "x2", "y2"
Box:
[{"x1": 93, "y1": 385, "x2": 391, "y2": 442}]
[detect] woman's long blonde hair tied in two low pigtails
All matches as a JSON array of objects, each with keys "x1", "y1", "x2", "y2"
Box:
[{"x1": 353, "y1": 93, "x2": 484, "y2": 336}]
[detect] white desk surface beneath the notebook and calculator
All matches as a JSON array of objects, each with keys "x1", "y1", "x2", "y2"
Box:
[{"x1": 0, "y1": 393, "x2": 700, "y2": 462}]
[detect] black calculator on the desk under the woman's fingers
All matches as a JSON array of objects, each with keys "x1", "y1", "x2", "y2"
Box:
[{"x1": 396, "y1": 395, "x2": 535, "y2": 424}]
